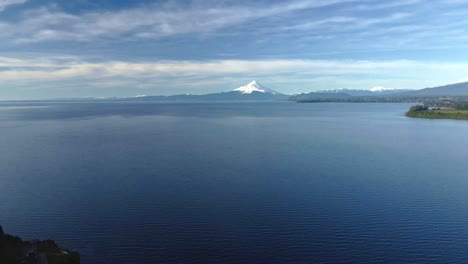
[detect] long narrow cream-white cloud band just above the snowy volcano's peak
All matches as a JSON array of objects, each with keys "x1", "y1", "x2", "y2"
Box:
[{"x1": 0, "y1": 58, "x2": 420, "y2": 81}]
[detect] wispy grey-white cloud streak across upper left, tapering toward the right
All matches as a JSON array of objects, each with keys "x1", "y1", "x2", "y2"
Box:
[{"x1": 0, "y1": 0, "x2": 355, "y2": 43}]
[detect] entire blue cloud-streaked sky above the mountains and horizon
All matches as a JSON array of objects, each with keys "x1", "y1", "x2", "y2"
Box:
[{"x1": 0, "y1": 0, "x2": 468, "y2": 100}]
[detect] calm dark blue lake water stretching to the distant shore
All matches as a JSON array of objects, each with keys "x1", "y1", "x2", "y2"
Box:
[{"x1": 0, "y1": 102, "x2": 468, "y2": 264}]
